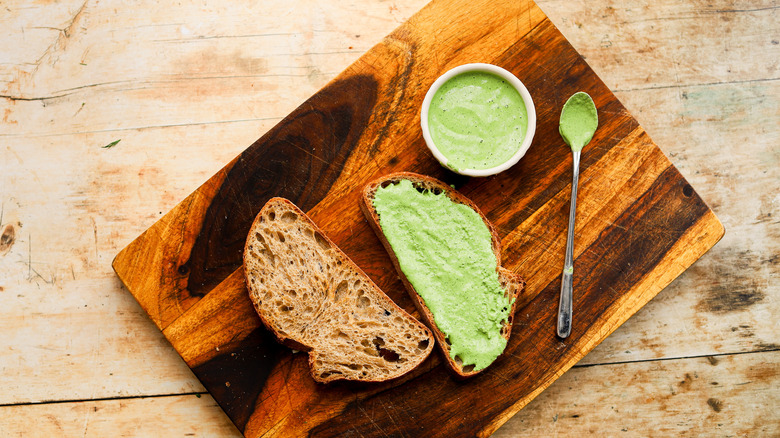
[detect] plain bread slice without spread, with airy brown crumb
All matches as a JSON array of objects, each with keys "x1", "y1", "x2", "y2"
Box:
[{"x1": 244, "y1": 198, "x2": 433, "y2": 383}]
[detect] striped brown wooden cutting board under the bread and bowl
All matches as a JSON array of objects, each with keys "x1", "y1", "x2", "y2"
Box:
[{"x1": 113, "y1": 0, "x2": 724, "y2": 437}]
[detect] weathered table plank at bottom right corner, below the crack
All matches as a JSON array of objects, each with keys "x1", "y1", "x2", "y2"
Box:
[{"x1": 493, "y1": 351, "x2": 780, "y2": 438}]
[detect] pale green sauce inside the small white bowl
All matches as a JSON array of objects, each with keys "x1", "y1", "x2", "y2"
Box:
[{"x1": 428, "y1": 71, "x2": 528, "y2": 170}]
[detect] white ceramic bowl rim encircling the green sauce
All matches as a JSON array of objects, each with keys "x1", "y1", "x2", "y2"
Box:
[{"x1": 420, "y1": 63, "x2": 536, "y2": 176}]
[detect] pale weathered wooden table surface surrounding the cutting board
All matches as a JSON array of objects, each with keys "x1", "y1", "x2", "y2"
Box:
[{"x1": 0, "y1": 0, "x2": 780, "y2": 436}]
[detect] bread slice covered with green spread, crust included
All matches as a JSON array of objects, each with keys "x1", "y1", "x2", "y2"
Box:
[{"x1": 361, "y1": 172, "x2": 525, "y2": 377}]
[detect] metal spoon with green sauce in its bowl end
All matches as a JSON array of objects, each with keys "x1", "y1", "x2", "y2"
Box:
[{"x1": 558, "y1": 91, "x2": 599, "y2": 338}]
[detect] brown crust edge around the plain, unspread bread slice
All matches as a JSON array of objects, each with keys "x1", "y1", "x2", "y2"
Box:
[{"x1": 243, "y1": 197, "x2": 433, "y2": 383}]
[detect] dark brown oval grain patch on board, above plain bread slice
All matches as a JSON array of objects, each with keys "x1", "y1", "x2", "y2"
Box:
[{"x1": 182, "y1": 75, "x2": 376, "y2": 296}]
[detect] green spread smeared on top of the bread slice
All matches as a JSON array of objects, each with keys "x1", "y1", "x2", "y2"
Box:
[{"x1": 374, "y1": 180, "x2": 512, "y2": 370}]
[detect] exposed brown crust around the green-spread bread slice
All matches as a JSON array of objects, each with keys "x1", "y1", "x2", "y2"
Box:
[{"x1": 360, "y1": 172, "x2": 525, "y2": 377}]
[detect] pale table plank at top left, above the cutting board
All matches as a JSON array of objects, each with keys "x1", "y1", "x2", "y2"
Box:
[{"x1": 0, "y1": 0, "x2": 425, "y2": 139}]
